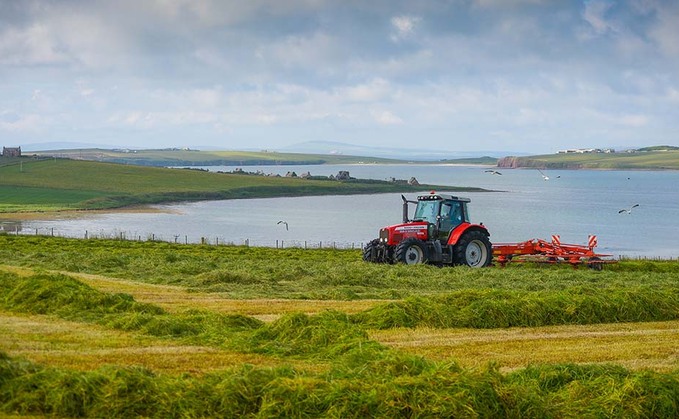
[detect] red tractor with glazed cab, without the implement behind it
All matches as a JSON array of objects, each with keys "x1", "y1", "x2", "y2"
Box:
[{"x1": 363, "y1": 192, "x2": 493, "y2": 268}]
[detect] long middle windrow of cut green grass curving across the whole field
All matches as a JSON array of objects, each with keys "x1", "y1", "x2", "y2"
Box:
[{"x1": 0, "y1": 271, "x2": 679, "y2": 358}]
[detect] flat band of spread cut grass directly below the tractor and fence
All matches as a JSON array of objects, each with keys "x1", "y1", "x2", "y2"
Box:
[{"x1": 0, "y1": 234, "x2": 679, "y2": 300}]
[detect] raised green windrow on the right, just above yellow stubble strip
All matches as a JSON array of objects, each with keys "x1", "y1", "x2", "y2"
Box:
[{"x1": 354, "y1": 286, "x2": 679, "y2": 329}]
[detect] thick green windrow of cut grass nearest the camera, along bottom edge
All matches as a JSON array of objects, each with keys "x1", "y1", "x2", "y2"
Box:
[{"x1": 0, "y1": 353, "x2": 679, "y2": 418}]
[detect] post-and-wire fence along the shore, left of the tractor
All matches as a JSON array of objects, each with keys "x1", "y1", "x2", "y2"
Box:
[{"x1": 5, "y1": 227, "x2": 365, "y2": 250}]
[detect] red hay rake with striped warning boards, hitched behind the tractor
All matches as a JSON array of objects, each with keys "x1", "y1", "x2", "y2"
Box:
[{"x1": 493, "y1": 235, "x2": 615, "y2": 271}]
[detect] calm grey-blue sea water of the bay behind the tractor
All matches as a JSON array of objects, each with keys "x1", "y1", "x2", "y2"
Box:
[{"x1": 13, "y1": 164, "x2": 679, "y2": 258}]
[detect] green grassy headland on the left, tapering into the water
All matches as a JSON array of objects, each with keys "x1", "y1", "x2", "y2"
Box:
[{"x1": 0, "y1": 158, "x2": 479, "y2": 213}]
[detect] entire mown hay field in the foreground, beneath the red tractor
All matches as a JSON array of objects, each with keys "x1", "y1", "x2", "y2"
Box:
[{"x1": 0, "y1": 234, "x2": 679, "y2": 417}]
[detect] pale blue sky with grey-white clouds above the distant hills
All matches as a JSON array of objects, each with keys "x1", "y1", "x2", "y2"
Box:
[{"x1": 0, "y1": 0, "x2": 679, "y2": 154}]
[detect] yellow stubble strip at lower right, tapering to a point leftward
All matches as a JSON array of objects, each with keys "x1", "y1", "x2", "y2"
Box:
[{"x1": 369, "y1": 320, "x2": 679, "y2": 372}]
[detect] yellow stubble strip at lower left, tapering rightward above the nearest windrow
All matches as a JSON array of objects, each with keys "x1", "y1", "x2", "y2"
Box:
[{"x1": 0, "y1": 311, "x2": 314, "y2": 375}]
